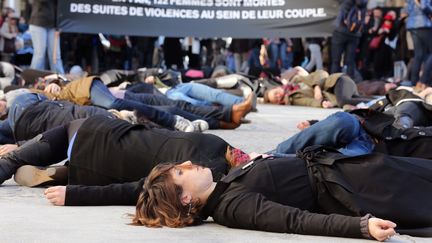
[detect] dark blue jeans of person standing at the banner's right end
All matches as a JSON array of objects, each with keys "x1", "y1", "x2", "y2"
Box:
[{"x1": 331, "y1": 31, "x2": 360, "y2": 78}]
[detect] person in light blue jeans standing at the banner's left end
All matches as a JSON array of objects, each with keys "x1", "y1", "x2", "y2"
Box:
[{"x1": 29, "y1": 0, "x2": 64, "y2": 74}]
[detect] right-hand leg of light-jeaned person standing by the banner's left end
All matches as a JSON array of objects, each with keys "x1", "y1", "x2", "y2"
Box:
[{"x1": 47, "y1": 28, "x2": 64, "y2": 74}]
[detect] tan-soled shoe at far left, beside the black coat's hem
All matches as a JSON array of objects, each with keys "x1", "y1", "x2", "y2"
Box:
[{"x1": 14, "y1": 165, "x2": 68, "y2": 187}]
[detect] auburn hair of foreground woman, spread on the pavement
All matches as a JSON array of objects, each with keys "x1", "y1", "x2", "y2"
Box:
[{"x1": 132, "y1": 163, "x2": 201, "y2": 228}]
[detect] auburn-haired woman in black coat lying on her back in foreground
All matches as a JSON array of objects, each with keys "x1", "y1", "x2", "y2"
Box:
[{"x1": 133, "y1": 147, "x2": 432, "y2": 241}]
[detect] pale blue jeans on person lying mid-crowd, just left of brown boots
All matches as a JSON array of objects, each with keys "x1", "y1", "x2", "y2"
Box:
[{"x1": 166, "y1": 83, "x2": 244, "y2": 107}]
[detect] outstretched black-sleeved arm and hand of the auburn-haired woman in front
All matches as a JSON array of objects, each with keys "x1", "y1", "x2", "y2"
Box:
[{"x1": 213, "y1": 192, "x2": 396, "y2": 240}]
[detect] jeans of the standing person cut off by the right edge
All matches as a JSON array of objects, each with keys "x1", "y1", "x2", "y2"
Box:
[{"x1": 409, "y1": 28, "x2": 432, "y2": 83}]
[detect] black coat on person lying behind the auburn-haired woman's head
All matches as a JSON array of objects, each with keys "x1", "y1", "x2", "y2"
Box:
[{"x1": 66, "y1": 116, "x2": 229, "y2": 205}]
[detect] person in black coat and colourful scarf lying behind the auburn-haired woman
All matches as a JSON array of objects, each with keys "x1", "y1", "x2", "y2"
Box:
[{"x1": 0, "y1": 115, "x2": 249, "y2": 199}]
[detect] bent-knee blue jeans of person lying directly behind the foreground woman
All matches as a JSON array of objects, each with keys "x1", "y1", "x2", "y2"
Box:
[{"x1": 271, "y1": 112, "x2": 375, "y2": 156}]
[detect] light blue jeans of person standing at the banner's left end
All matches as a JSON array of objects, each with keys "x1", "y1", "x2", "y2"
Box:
[{"x1": 29, "y1": 25, "x2": 64, "y2": 74}]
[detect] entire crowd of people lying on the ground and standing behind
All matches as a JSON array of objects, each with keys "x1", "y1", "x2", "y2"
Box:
[{"x1": 0, "y1": 0, "x2": 432, "y2": 241}]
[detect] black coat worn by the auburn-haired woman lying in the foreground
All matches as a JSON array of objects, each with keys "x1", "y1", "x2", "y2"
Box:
[{"x1": 203, "y1": 150, "x2": 432, "y2": 237}]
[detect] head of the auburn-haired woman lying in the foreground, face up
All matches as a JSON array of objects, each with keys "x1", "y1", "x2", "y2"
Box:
[{"x1": 132, "y1": 161, "x2": 214, "y2": 228}]
